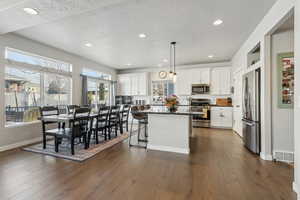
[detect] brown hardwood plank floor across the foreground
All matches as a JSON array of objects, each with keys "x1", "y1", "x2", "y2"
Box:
[{"x1": 0, "y1": 129, "x2": 296, "y2": 200}]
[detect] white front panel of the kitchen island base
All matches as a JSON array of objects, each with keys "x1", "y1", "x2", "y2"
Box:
[{"x1": 147, "y1": 113, "x2": 190, "y2": 154}]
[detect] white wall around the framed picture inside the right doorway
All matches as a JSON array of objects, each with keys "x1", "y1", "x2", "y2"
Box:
[{"x1": 272, "y1": 30, "x2": 294, "y2": 155}]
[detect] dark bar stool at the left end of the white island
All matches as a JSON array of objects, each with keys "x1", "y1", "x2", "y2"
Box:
[{"x1": 129, "y1": 106, "x2": 148, "y2": 149}]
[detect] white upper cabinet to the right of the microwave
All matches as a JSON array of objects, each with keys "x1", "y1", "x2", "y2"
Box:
[{"x1": 211, "y1": 67, "x2": 231, "y2": 95}]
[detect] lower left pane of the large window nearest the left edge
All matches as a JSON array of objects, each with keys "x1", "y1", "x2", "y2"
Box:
[{"x1": 5, "y1": 67, "x2": 41, "y2": 124}]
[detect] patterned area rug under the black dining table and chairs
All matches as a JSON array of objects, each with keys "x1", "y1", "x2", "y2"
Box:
[{"x1": 23, "y1": 133, "x2": 129, "y2": 162}]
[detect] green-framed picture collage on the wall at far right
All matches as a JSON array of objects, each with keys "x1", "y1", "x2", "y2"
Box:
[{"x1": 277, "y1": 52, "x2": 295, "y2": 109}]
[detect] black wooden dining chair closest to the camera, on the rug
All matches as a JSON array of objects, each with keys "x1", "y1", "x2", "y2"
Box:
[{"x1": 46, "y1": 108, "x2": 90, "y2": 155}]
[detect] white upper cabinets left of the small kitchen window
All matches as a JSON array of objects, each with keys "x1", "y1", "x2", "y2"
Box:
[{"x1": 117, "y1": 73, "x2": 148, "y2": 96}]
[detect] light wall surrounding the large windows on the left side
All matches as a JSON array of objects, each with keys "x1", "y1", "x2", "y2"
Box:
[{"x1": 0, "y1": 34, "x2": 116, "y2": 151}]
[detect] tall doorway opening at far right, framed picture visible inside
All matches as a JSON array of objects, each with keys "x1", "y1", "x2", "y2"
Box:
[{"x1": 271, "y1": 14, "x2": 295, "y2": 163}]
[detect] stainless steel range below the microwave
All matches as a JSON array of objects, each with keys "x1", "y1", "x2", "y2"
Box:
[{"x1": 190, "y1": 98, "x2": 210, "y2": 128}]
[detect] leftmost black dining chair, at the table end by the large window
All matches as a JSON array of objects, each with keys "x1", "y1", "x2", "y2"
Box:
[{"x1": 40, "y1": 106, "x2": 62, "y2": 149}]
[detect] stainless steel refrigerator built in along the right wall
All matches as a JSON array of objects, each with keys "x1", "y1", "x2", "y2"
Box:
[{"x1": 242, "y1": 69, "x2": 261, "y2": 154}]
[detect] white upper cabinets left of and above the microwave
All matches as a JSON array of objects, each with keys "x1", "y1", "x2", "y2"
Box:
[{"x1": 175, "y1": 68, "x2": 210, "y2": 95}]
